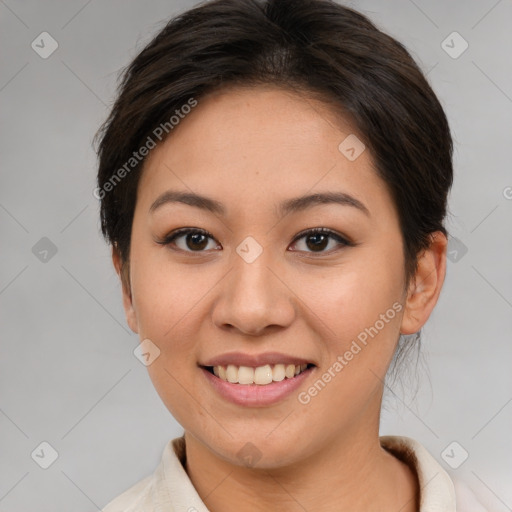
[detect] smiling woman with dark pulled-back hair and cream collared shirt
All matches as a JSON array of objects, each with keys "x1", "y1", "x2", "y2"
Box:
[{"x1": 96, "y1": 0, "x2": 472, "y2": 512}]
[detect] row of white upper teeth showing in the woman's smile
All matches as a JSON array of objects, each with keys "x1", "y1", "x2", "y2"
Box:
[{"x1": 213, "y1": 364, "x2": 308, "y2": 386}]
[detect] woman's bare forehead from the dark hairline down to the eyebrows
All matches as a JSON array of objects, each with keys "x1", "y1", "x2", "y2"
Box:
[{"x1": 139, "y1": 86, "x2": 391, "y2": 221}]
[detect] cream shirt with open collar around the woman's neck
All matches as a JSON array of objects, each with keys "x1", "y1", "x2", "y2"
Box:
[{"x1": 102, "y1": 436, "x2": 485, "y2": 512}]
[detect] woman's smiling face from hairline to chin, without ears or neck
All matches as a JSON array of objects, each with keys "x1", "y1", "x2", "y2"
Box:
[{"x1": 115, "y1": 87, "x2": 438, "y2": 467}]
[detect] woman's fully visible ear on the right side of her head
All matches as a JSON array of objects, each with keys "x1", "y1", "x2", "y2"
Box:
[{"x1": 400, "y1": 231, "x2": 448, "y2": 334}]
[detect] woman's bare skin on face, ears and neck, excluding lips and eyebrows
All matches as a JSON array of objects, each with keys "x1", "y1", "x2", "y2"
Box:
[{"x1": 113, "y1": 86, "x2": 447, "y2": 512}]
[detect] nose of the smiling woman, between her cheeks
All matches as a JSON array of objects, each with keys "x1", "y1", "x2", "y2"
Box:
[{"x1": 212, "y1": 250, "x2": 297, "y2": 336}]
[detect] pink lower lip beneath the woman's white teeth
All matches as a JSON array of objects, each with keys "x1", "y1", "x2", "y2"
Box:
[{"x1": 201, "y1": 367, "x2": 313, "y2": 407}]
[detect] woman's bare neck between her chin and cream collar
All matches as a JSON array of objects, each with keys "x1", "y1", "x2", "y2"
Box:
[{"x1": 185, "y1": 422, "x2": 419, "y2": 512}]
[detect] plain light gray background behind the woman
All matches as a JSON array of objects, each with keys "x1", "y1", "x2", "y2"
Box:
[{"x1": 0, "y1": 0, "x2": 512, "y2": 512}]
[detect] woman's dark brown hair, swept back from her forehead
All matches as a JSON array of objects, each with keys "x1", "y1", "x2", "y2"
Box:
[{"x1": 96, "y1": 0, "x2": 453, "y2": 384}]
